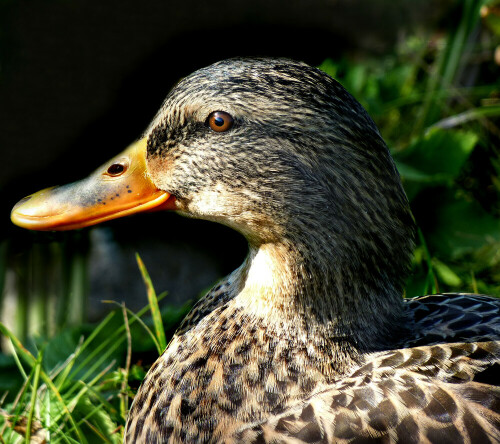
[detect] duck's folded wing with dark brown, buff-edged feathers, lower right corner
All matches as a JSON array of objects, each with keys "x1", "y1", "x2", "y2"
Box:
[{"x1": 227, "y1": 341, "x2": 500, "y2": 444}]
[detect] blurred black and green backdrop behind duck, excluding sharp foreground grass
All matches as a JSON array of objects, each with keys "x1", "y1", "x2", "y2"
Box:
[{"x1": 0, "y1": 0, "x2": 500, "y2": 442}]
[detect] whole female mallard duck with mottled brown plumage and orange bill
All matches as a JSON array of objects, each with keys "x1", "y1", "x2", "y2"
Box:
[{"x1": 12, "y1": 59, "x2": 500, "y2": 443}]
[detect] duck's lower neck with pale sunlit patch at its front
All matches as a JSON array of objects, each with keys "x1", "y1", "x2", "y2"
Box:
[{"x1": 236, "y1": 241, "x2": 404, "y2": 358}]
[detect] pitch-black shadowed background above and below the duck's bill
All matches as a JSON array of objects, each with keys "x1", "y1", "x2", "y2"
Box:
[{"x1": 0, "y1": 0, "x2": 457, "y2": 320}]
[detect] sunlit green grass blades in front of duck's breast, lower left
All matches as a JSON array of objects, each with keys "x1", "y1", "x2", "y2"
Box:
[{"x1": 0, "y1": 282, "x2": 190, "y2": 443}]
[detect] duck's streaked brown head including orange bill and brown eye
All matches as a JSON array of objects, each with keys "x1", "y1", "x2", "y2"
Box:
[{"x1": 12, "y1": 58, "x2": 414, "y2": 348}]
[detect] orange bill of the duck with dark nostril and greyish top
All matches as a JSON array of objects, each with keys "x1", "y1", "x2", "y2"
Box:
[{"x1": 11, "y1": 139, "x2": 175, "y2": 231}]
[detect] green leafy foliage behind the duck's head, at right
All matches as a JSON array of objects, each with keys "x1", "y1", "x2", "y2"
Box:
[{"x1": 320, "y1": 0, "x2": 500, "y2": 296}]
